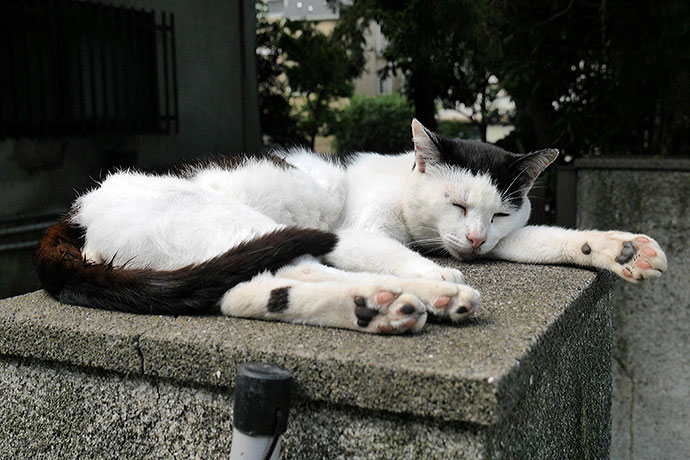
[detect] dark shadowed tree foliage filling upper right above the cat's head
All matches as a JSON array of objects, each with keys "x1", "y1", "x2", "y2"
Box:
[{"x1": 331, "y1": 0, "x2": 690, "y2": 156}]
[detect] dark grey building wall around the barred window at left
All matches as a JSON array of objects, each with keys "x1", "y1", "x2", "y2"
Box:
[{"x1": 0, "y1": 0, "x2": 260, "y2": 297}]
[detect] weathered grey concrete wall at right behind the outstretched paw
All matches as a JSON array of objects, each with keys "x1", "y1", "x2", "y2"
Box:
[{"x1": 576, "y1": 158, "x2": 690, "y2": 460}]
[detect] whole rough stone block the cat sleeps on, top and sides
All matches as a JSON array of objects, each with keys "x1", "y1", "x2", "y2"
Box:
[{"x1": 0, "y1": 263, "x2": 611, "y2": 458}]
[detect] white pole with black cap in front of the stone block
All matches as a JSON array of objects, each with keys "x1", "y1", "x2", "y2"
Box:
[{"x1": 230, "y1": 363, "x2": 292, "y2": 460}]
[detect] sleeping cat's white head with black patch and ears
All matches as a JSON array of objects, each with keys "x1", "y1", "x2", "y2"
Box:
[{"x1": 403, "y1": 120, "x2": 558, "y2": 258}]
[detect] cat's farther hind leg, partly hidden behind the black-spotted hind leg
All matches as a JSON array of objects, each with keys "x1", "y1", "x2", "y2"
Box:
[{"x1": 276, "y1": 256, "x2": 480, "y2": 321}]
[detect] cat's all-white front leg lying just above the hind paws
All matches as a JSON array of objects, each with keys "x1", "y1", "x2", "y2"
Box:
[{"x1": 324, "y1": 230, "x2": 465, "y2": 284}]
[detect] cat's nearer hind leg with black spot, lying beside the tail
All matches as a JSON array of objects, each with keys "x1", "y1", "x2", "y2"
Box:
[{"x1": 220, "y1": 273, "x2": 427, "y2": 334}]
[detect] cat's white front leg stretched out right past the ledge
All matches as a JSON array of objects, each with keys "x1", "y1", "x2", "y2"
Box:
[{"x1": 488, "y1": 226, "x2": 666, "y2": 282}]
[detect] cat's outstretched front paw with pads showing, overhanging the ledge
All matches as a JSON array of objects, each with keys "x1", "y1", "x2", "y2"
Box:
[{"x1": 581, "y1": 232, "x2": 667, "y2": 283}]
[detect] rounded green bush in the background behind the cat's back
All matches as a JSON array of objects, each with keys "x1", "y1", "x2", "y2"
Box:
[{"x1": 331, "y1": 94, "x2": 413, "y2": 153}]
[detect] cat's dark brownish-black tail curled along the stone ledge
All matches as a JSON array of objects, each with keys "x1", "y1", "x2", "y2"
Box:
[{"x1": 34, "y1": 220, "x2": 338, "y2": 315}]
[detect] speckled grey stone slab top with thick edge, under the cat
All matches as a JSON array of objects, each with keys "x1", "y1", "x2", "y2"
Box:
[{"x1": 0, "y1": 259, "x2": 612, "y2": 425}]
